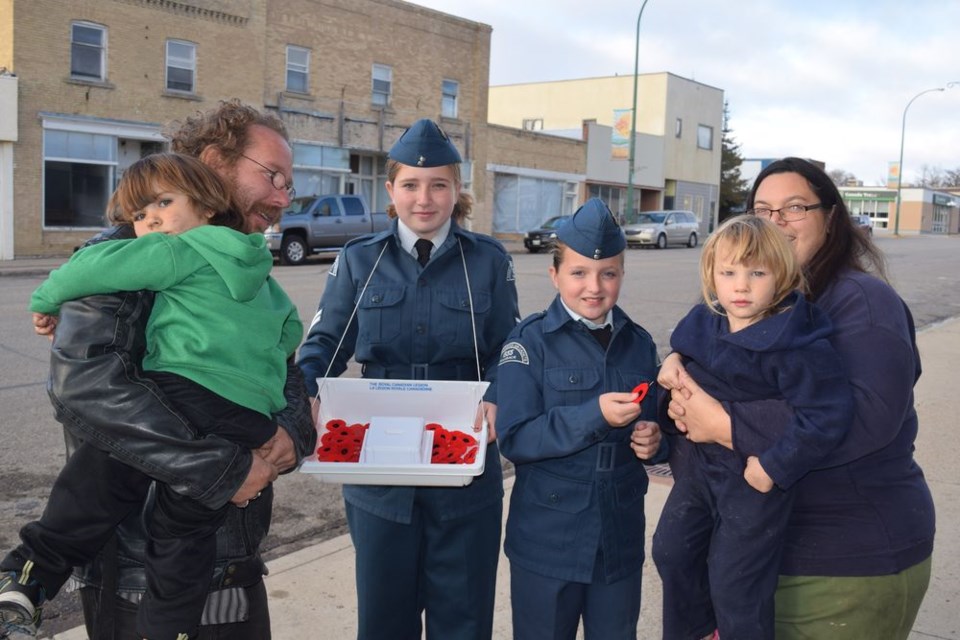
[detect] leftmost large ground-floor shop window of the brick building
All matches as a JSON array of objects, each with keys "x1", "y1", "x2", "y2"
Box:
[{"x1": 43, "y1": 129, "x2": 117, "y2": 227}]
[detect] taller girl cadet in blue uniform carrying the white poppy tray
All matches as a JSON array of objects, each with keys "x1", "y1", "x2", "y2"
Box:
[{"x1": 299, "y1": 119, "x2": 519, "y2": 640}]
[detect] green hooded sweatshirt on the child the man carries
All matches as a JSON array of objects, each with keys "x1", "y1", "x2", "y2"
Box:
[{"x1": 30, "y1": 225, "x2": 303, "y2": 415}]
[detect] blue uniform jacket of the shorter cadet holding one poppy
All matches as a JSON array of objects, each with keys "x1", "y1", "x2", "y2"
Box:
[{"x1": 497, "y1": 296, "x2": 666, "y2": 583}]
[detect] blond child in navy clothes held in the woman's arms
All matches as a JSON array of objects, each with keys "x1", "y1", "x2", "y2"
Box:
[{"x1": 653, "y1": 215, "x2": 853, "y2": 640}]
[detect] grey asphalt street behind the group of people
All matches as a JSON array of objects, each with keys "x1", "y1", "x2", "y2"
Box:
[{"x1": 0, "y1": 236, "x2": 960, "y2": 633}]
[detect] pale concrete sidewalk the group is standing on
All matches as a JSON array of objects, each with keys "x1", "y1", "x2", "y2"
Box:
[{"x1": 48, "y1": 320, "x2": 960, "y2": 640}]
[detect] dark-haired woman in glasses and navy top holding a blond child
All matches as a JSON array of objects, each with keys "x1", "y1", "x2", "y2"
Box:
[{"x1": 654, "y1": 158, "x2": 934, "y2": 640}]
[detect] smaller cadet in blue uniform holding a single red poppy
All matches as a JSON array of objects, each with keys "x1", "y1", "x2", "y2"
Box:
[{"x1": 497, "y1": 198, "x2": 666, "y2": 640}]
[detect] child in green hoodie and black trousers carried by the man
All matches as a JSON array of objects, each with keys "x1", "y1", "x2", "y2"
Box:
[{"x1": 0, "y1": 153, "x2": 303, "y2": 640}]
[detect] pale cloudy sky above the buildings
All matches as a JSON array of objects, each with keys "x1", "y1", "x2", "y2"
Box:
[{"x1": 413, "y1": 0, "x2": 960, "y2": 185}]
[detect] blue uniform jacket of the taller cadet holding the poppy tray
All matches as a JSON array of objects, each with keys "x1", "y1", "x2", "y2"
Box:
[{"x1": 298, "y1": 220, "x2": 519, "y2": 523}]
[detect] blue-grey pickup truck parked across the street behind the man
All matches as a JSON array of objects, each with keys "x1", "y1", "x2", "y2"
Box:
[{"x1": 264, "y1": 195, "x2": 390, "y2": 264}]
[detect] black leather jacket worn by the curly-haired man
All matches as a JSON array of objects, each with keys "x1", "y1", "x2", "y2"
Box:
[{"x1": 48, "y1": 227, "x2": 316, "y2": 591}]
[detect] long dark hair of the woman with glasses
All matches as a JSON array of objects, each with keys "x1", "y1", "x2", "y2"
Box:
[{"x1": 746, "y1": 158, "x2": 887, "y2": 300}]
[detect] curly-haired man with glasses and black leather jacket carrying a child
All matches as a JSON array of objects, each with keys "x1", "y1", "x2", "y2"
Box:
[{"x1": 15, "y1": 100, "x2": 316, "y2": 640}]
